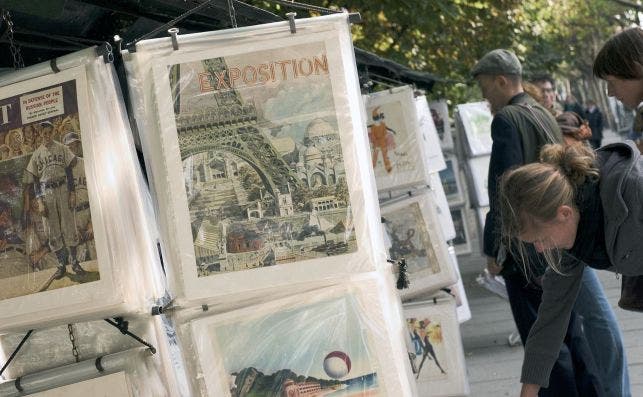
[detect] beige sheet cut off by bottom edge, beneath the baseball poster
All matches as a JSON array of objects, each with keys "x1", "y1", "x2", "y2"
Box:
[{"x1": 30, "y1": 372, "x2": 132, "y2": 397}]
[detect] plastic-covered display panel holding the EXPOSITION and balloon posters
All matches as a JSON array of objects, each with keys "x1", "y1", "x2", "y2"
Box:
[{"x1": 123, "y1": 14, "x2": 416, "y2": 396}]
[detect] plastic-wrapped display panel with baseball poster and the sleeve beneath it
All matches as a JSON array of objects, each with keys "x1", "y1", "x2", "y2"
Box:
[{"x1": 0, "y1": 47, "x2": 174, "y2": 396}]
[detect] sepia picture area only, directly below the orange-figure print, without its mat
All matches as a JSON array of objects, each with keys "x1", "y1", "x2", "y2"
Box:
[{"x1": 383, "y1": 201, "x2": 440, "y2": 273}]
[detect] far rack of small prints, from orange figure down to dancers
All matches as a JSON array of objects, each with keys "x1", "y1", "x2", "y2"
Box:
[{"x1": 364, "y1": 86, "x2": 471, "y2": 396}]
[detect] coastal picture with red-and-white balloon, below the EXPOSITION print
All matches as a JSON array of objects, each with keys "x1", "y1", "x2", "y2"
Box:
[{"x1": 210, "y1": 294, "x2": 381, "y2": 397}]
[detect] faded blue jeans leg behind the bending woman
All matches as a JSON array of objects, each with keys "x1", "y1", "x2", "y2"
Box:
[{"x1": 574, "y1": 267, "x2": 631, "y2": 397}]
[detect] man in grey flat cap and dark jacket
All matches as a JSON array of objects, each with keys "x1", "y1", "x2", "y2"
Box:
[{"x1": 471, "y1": 49, "x2": 608, "y2": 396}]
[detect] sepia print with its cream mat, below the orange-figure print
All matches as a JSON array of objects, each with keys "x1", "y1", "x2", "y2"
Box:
[{"x1": 381, "y1": 191, "x2": 457, "y2": 299}]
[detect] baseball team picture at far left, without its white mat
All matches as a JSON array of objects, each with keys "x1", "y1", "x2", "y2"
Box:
[{"x1": 0, "y1": 80, "x2": 100, "y2": 300}]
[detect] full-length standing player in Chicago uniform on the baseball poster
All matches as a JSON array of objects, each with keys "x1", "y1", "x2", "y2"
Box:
[{"x1": 23, "y1": 121, "x2": 85, "y2": 279}]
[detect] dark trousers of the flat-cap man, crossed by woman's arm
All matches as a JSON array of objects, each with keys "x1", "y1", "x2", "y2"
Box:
[{"x1": 504, "y1": 273, "x2": 603, "y2": 397}]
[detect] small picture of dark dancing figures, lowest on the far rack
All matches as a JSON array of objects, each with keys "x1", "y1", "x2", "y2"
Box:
[{"x1": 406, "y1": 316, "x2": 449, "y2": 382}]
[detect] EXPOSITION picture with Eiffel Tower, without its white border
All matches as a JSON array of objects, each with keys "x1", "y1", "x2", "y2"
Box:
[{"x1": 170, "y1": 42, "x2": 357, "y2": 277}]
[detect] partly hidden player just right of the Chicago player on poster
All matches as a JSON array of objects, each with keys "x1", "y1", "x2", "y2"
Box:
[{"x1": 63, "y1": 132, "x2": 96, "y2": 262}]
